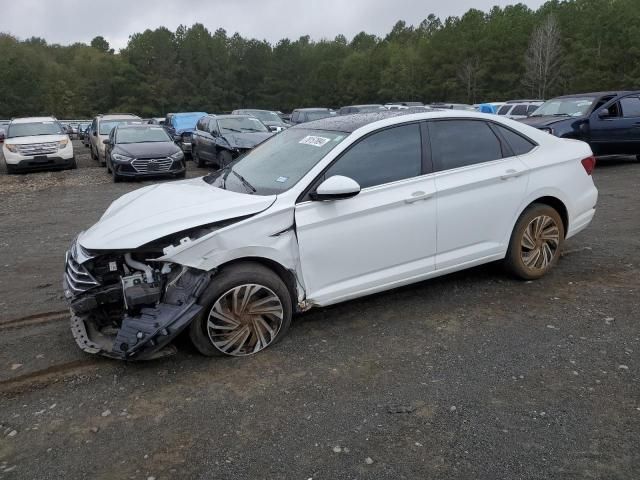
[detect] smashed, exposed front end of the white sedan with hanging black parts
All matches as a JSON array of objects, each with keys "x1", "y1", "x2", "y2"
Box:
[{"x1": 63, "y1": 242, "x2": 212, "y2": 360}]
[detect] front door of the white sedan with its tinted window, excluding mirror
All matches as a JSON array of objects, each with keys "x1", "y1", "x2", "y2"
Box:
[{"x1": 295, "y1": 123, "x2": 436, "y2": 305}]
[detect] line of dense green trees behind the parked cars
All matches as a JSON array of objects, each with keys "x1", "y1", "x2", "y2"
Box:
[{"x1": 0, "y1": 0, "x2": 640, "y2": 118}]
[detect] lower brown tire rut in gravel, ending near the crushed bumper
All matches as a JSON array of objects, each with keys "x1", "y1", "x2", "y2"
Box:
[{"x1": 0, "y1": 359, "x2": 100, "y2": 397}]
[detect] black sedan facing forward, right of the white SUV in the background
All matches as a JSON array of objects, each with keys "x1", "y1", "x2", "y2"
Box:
[{"x1": 104, "y1": 124, "x2": 186, "y2": 182}]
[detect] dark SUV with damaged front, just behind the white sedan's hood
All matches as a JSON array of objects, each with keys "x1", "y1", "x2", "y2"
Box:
[{"x1": 192, "y1": 115, "x2": 274, "y2": 168}]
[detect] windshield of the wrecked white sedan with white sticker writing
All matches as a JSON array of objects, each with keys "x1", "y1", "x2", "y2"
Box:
[{"x1": 205, "y1": 128, "x2": 348, "y2": 195}]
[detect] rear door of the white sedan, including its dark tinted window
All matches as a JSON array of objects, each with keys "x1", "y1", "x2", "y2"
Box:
[{"x1": 428, "y1": 119, "x2": 528, "y2": 270}]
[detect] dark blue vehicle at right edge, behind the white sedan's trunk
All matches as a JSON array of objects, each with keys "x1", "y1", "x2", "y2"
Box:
[{"x1": 520, "y1": 91, "x2": 640, "y2": 161}]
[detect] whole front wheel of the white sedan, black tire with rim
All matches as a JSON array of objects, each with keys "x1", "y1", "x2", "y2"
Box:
[{"x1": 189, "y1": 262, "x2": 293, "y2": 357}]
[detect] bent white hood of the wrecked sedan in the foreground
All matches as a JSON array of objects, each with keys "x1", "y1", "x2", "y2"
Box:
[{"x1": 78, "y1": 177, "x2": 276, "y2": 250}]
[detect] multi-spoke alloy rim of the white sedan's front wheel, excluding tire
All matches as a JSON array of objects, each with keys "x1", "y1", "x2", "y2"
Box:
[{"x1": 207, "y1": 284, "x2": 284, "y2": 356}]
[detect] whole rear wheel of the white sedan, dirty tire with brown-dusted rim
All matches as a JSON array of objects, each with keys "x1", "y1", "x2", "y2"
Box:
[{"x1": 505, "y1": 203, "x2": 565, "y2": 280}]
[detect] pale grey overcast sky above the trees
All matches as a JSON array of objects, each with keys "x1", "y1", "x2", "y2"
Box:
[{"x1": 0, "y1": 0, "x2": 543, "y2": 49}]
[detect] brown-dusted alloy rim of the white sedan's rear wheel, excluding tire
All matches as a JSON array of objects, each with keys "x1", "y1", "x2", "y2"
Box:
[{"x1": 520, "y1": 215, "x2": 560, "y2": 270}]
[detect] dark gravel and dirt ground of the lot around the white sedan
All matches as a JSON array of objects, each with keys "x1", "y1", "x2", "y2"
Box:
[{"x1": 0, "y1": 145, "x2": 640, "y2": 480}]
